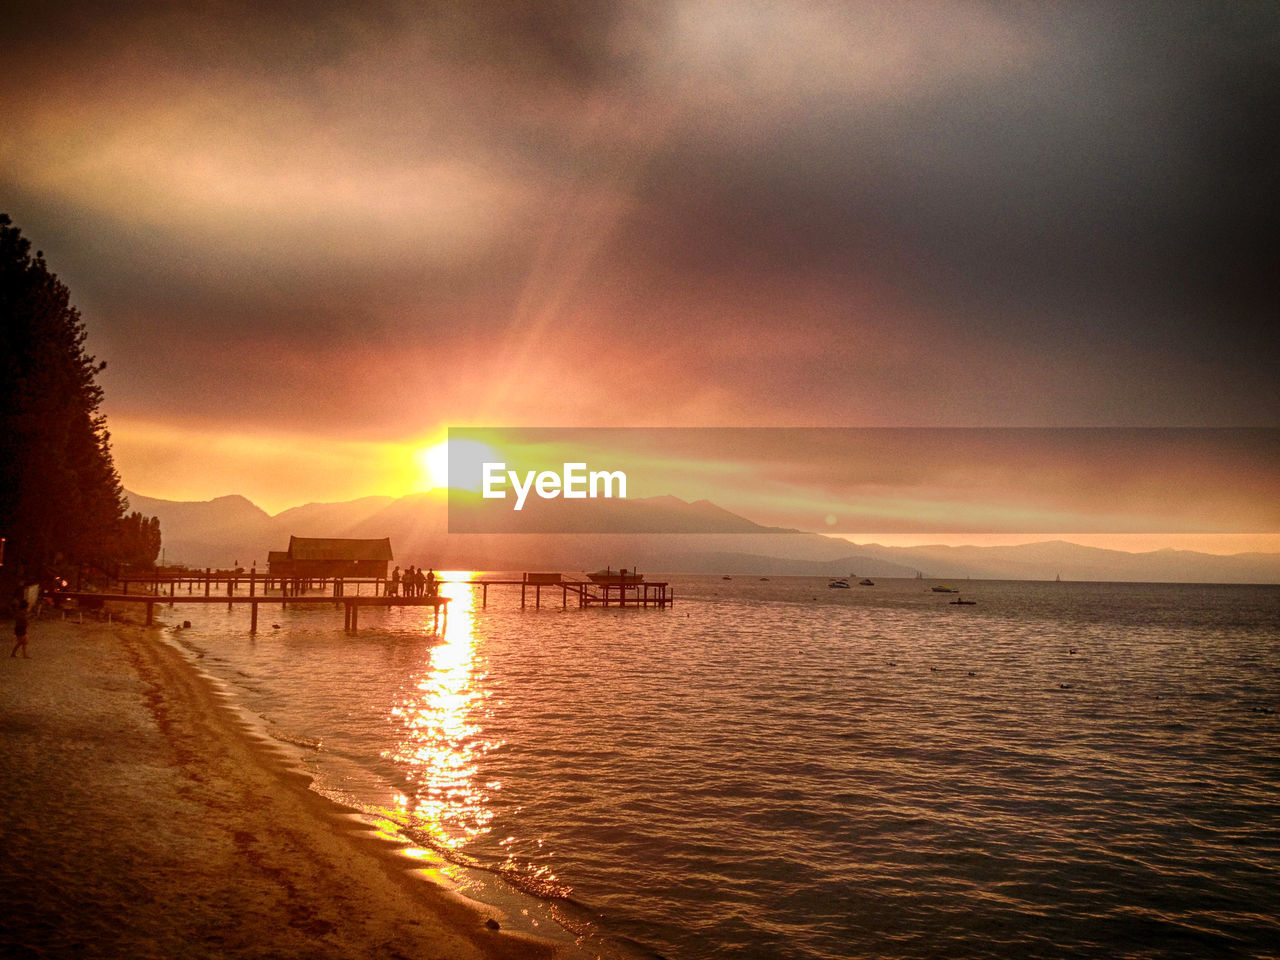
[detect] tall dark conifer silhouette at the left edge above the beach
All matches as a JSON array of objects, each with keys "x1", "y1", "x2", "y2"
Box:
[{"x1": 0, "y1": 214, "x2": 135, "y2": 580}]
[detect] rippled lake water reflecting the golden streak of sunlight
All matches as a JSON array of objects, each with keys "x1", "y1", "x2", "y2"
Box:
[{"x1": 169, "y1": 576, "x2": 1280, "y2": 960}]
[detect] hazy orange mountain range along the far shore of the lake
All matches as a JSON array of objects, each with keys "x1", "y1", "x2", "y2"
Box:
[{"x1": 125, "y1": 490, "x2": 1280, "y2": 584}]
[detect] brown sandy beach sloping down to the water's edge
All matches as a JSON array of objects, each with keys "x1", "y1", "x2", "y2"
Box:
[{"x1": 0, "y1": 620, "x2": 568, "y2": 960}]
